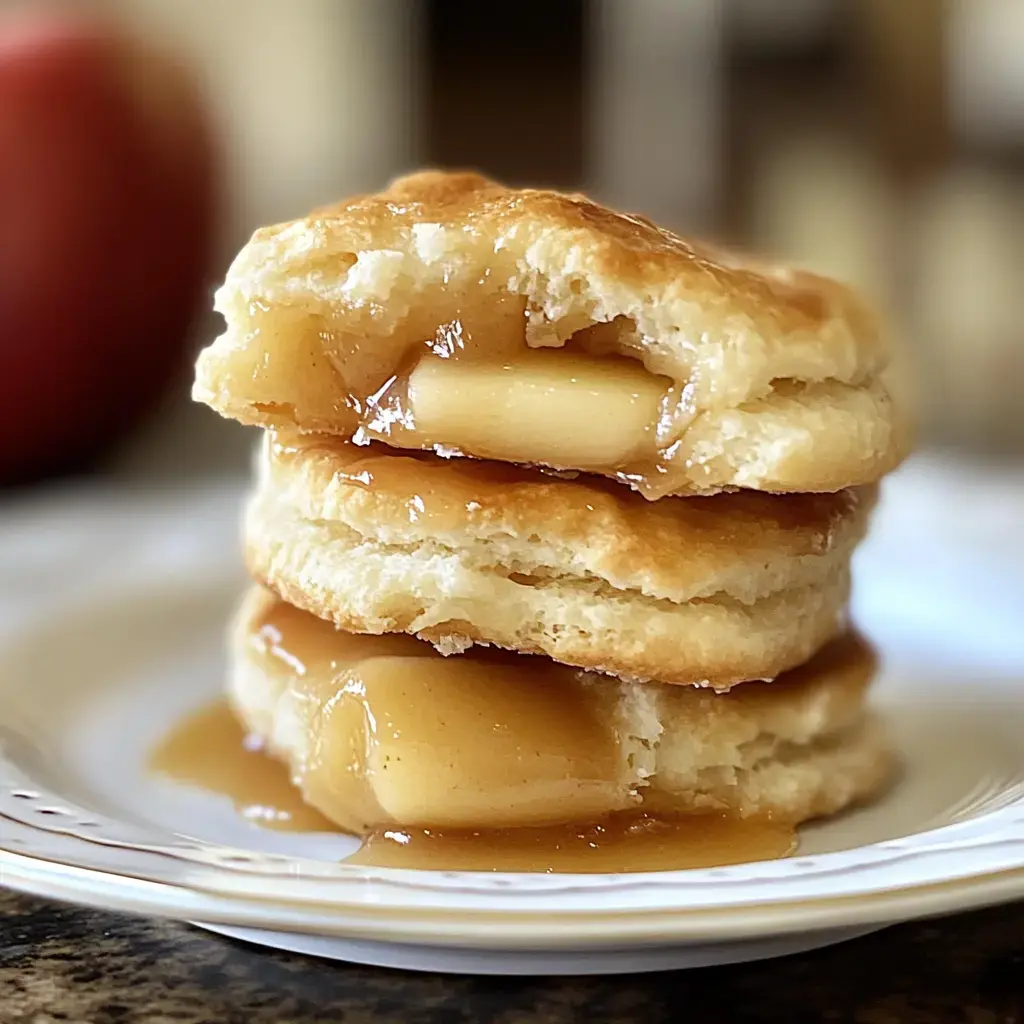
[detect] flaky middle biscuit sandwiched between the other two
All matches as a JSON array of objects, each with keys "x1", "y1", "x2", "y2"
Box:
[{"x1": 245, "y1": 434, "x2": 876, "y2": 689}]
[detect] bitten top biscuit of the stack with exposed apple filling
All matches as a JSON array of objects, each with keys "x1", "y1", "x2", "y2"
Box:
[{"x1": 194, "y1": 172, "x2": 906, "y2": 499}]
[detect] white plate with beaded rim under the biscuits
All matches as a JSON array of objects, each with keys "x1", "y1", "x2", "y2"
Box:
[{"x1": 0, "y1": 461, "x2": 1024, "y2": 973}]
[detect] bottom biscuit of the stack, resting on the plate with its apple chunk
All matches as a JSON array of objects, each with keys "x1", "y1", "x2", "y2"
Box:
[{"x1": 230, "y1": 588, "x2": 892, "y2": 831}]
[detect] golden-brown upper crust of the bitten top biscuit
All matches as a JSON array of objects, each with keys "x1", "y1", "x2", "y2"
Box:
[{"x1": 232, "y1": 171, "x2": 887, "y2": 344}]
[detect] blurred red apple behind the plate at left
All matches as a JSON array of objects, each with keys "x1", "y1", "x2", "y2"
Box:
[{"x1": 0, "y1": 15, "x2": 215, "y2": 482}]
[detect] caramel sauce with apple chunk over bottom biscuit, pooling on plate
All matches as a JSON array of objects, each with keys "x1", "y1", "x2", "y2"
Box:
[{"x1": 150, "y1": 592, "x2": 796, "y2": 872}]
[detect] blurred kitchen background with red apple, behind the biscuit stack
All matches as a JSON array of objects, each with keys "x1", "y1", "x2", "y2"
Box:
[{"x1": 0, "y1": 0, "x2": 1024, "y2": 482}]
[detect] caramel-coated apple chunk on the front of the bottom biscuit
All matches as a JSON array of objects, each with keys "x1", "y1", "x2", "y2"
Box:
[{"x1": 359, "y1": 657, "x2": 630, "y2": 828}]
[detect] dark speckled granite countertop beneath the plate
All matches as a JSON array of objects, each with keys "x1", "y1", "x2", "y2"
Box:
[{"x1": 0, "y1": 891, "x2": 1024, "y2": 1024}]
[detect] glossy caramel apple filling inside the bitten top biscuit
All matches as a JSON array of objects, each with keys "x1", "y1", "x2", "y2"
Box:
[{"x1": 230, "y1": 292, "x2": 693, "y2": 498}]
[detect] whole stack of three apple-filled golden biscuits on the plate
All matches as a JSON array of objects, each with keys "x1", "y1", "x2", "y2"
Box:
[{"x1": 195, "y1": 172, "x2": 905, "y2": 831}]
